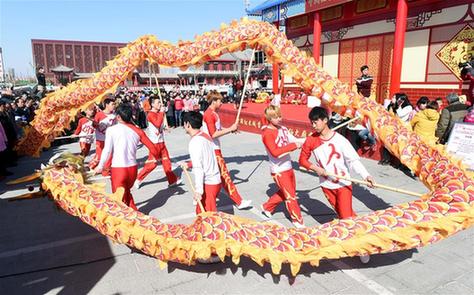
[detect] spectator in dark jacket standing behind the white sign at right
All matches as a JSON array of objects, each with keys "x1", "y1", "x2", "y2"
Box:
[{"x1": 435, "y1": 93, "x2": 468, "y2": 144}]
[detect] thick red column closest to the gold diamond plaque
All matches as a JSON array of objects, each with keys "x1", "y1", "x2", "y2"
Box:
[{"x1": 390, "y1": 0, "x2": 408, "y2": 96}]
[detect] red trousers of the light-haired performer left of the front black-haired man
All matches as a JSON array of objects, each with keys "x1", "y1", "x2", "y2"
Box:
[{"x1": 263, "y1": 169, "x2": 303, "y2": 224}]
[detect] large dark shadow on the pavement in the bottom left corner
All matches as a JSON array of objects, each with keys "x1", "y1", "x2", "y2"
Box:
[{"x1": 0, "y1": 198, "x2": 115, "y2": 294}]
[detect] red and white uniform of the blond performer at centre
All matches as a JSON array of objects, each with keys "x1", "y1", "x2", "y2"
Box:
[{"x1": 201, "y1": 108, "x2": 242, "y2": 205}]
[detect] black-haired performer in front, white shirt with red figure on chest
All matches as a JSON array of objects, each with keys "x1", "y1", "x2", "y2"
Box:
[{"x1": 299, "y1": 107, "x2": 375, "y2": 263}]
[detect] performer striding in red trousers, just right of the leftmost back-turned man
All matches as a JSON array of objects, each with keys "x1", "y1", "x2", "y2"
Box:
[{"x1": 135, "y1": 96, "x2": 182, "y2": 189}]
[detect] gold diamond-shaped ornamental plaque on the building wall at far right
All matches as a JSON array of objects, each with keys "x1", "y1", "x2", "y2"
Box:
[{"x1": 436, "y1": 25, "x2": 474, "y2": 80}]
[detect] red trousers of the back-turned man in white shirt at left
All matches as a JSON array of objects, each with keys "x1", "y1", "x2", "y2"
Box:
[{"x1": 110, "y1": 165, "x2": 138, "y2": 211}]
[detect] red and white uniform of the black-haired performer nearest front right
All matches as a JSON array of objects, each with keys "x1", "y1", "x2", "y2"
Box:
[{"x1": 299, "y1": 132, "x2": 370, "y2": 219}]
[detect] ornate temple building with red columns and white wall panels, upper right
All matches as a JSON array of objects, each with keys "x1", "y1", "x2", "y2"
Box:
[{"x1": 248, "y1": 0, "x2": 474, "y2": 101}]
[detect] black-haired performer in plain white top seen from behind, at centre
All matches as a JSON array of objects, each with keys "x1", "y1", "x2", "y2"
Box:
[{"x1": 182, "y1": 112, "x2": 221, "y2": 214}]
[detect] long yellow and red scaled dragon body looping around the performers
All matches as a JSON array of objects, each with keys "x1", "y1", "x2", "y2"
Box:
[{"x1": 14, "y1": 19, "x2": 474, "y2": 274}]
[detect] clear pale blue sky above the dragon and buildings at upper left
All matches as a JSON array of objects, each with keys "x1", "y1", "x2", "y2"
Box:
[{"x1": 0, "y1": 0, "x2": 263, "y2": 77}]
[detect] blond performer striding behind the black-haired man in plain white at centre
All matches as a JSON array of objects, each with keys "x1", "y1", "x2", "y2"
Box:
[{"x1": 202, "y1": 91, "x2": 252, "y2": 209}]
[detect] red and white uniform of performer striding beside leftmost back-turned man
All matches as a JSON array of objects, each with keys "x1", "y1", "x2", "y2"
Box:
[{"x1": 137, "y1": 111, "x2": 178, "y2": 184}]
